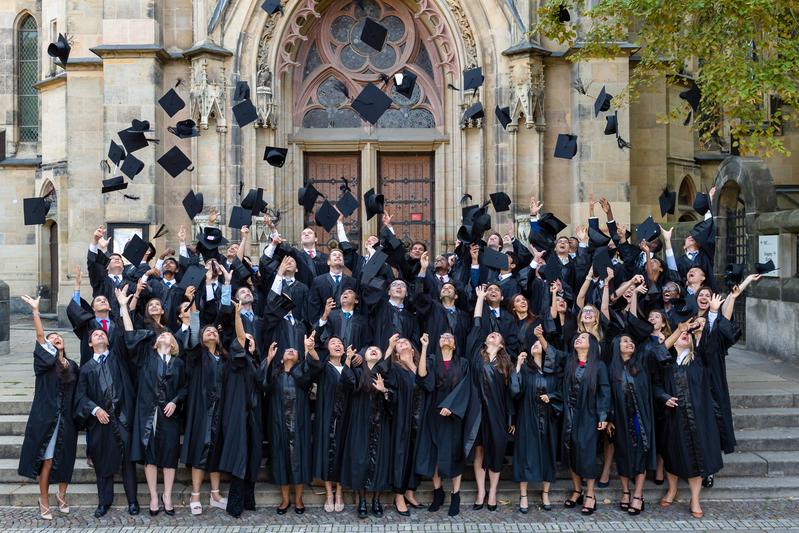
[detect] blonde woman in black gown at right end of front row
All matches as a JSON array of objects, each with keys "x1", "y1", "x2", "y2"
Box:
[{"x1": 655, "y1": 312, "x2": 723, "y2": 518}]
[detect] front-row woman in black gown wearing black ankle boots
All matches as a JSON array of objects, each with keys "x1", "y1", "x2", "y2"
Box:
[{"x1": 416, "y1": 332, "x2": 473, "y2": 516}]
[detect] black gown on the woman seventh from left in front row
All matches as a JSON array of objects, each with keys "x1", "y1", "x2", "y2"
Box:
[{"x1": 313, "y1": 361, "x2": 349, "y2": 482}]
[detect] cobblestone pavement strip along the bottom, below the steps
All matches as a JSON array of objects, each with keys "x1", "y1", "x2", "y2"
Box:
[{"x1": 0, "y1": 500, "x2": 799, "y2": 533}]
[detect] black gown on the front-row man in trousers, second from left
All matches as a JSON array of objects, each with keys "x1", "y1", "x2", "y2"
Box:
[{"x1": 75, "y1": 342, "x2": 136, "y2": 477}]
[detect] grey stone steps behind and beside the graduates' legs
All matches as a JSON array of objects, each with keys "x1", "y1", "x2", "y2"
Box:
[{"x1": 0, "y1": 332, "x2": 799, "y2": 506}]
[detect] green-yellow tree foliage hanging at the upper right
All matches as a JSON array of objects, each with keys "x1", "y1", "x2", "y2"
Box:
[{"x1": 532, "y1": 0, "x2": 799, "y2": 157}]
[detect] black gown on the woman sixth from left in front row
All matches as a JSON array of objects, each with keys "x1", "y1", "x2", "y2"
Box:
[{"x1": 266, "y1": 356, "x2": 324, "y2": 485}]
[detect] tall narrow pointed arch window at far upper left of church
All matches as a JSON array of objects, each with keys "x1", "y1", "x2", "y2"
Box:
[{"x1": 17, "y1": 15, "x2": 39, "y2": 142}]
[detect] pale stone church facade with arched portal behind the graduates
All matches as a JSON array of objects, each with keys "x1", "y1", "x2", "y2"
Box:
[{"x1": 0, "y1": 0, "x2": 796, "y2": 318}]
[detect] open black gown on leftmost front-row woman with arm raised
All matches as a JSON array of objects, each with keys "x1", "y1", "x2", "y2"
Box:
[{"x1": 17, "y1": 343, "x2": 78, "y2": 483}]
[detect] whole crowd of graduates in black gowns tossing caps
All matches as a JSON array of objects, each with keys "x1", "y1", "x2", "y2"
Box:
[{"x1": 19, "y1": 190, "x2": 759, "y2": 519}]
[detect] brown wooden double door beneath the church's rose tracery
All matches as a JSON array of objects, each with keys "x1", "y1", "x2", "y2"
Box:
[{"x1": 304, "y1": 152, "x2": 435, "y2": 250}]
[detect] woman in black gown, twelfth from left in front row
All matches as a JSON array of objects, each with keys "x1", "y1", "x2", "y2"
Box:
[{"x1": 510, "y1": 324, "x2": 563, "y2": 514}]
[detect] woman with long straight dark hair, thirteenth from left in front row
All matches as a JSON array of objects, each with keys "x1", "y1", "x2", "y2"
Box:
[{"x1": 561, "y1": 332, "x2": 610, "y2": 515}]
